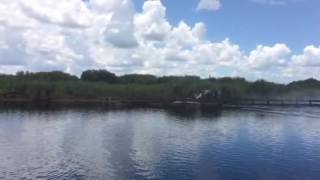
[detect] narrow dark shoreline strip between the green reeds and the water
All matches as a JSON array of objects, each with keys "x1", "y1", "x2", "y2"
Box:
[{"x1": 0, "y1": 98, "x2": 320, "y2": 112}]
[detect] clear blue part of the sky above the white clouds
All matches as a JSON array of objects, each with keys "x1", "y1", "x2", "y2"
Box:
[{"x1": 135, "y1": 0, "x2": 320, "y2": 52}]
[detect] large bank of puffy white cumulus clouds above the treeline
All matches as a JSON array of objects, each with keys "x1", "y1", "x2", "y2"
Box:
[{"x1": 0, "y1": 0, "x2": 320, "y2": 81}]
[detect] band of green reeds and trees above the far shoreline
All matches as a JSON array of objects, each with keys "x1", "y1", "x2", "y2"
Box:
[{"x1": 0, "y1": 70, "x2": 320, "y2": 101}]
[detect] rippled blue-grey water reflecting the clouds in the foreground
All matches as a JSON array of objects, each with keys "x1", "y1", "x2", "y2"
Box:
[{"x1": 0, "y1": 108, "x2": 320, "y2": 180}]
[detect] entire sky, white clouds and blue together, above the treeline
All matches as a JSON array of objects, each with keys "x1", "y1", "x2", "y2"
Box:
[{"x1": 0, "y1": 0, "x2": 320, "y2": 82}]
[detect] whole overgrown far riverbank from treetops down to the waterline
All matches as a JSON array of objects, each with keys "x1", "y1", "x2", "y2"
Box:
[{"x1": 0, "y1": 71, "x2": 320, "y2": 107}]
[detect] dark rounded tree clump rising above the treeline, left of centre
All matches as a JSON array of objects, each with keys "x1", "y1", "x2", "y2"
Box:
[{"x1": 81, "y1": 70, "x2": 117, "y2": 83}]
